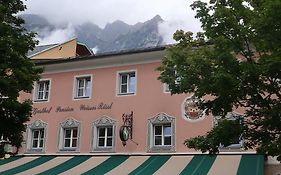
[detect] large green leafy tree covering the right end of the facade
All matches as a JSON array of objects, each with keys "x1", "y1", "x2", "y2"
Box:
[{"x1": 158, "y1": 0, "x2": 281, "y2": 160}]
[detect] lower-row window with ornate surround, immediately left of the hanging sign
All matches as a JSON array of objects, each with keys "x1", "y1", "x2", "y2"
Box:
[{"x1": 93, "y1": 116, "x2": 116, "y2": 152}]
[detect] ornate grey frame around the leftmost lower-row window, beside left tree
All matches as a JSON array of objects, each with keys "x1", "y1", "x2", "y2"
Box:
[{"x1": 26, "y1": 120, "x2": 47, "y2": 152}]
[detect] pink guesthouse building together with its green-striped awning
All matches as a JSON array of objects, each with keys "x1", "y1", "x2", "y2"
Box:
[{"x1": 0, "y1": 47, "x2": 263, "y2": 174}]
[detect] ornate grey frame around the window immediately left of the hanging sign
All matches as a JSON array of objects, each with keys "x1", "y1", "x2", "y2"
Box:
[{"x1": 92, "y1": 116, "x2": 117, "y2": 152}]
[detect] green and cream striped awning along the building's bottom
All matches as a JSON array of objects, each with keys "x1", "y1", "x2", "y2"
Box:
[{"x1": 0, "y1": 154, "x2": 264, "y2": 175}]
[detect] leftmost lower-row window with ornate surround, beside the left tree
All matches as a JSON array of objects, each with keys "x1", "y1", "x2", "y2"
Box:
[{"x1": 26, "y1": 120, "x2": 47, "y2": 152}]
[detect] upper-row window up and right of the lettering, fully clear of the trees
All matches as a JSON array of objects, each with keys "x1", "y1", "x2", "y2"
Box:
[{"x1": 118, "y1": 71, "x2": 136, "y2": 95}]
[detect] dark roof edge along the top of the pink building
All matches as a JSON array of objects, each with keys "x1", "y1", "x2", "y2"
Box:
[{"x1": 34, "y1": 46, "x2": 166, "y2": 65}]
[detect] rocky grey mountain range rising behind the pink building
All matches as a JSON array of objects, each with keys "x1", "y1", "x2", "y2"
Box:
[{"x1": 21, "y1": 14, "x2": 163, "y2": 53}]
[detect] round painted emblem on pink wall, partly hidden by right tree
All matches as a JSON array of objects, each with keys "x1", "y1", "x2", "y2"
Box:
[{"x1": 182, "y1": 95, "x2": 206, "y2": 121}]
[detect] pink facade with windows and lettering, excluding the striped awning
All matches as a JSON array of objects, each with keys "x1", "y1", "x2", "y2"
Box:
[{"x1": 20, "y1": 48, "x2": 217, "y2": 153}]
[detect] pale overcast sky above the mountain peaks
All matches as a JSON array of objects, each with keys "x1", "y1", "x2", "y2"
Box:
[{"x1": 25, "y1": 0, "x2": 201, "y2": 42}]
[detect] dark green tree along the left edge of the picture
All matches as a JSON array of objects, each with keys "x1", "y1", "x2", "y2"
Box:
[{"x1": 0, "y1": 0, "x2": 42, "y2": 153}]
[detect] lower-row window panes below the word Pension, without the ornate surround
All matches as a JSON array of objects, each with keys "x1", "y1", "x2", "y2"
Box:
[{"x1": 63, "y1": 128, "x2": 78, "y2": 148}]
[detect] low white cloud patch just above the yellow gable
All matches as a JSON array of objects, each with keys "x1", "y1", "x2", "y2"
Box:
[{"x1": 37, "y1": 24, "x2": 75, "y2": 45}]
